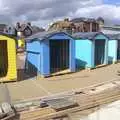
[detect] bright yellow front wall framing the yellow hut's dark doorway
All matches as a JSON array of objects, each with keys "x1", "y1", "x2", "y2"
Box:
[{"x1": 0, "y1": 35, "x2": 17, "y2": 81}]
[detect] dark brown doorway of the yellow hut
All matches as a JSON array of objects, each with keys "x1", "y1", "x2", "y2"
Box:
[{"x1": 0, "y1": 40, "x2": 8, "y2": 77}]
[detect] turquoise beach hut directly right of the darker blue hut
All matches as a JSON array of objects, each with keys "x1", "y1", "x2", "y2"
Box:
[{"x1": 73, "y1": 32, "x2": 108, "y2": 69}]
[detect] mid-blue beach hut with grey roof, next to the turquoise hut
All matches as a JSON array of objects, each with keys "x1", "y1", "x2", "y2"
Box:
[{"x1": 25, "y1": 32, "x2": 75, "y2": 77}]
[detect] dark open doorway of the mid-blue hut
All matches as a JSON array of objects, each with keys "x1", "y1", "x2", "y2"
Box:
[{"x1": 50, "y1": 40, "x2": 69, "y2": 73}]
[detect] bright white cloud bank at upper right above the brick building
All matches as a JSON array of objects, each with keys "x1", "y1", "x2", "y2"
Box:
[{"x1": 75, "y1": 4, "x2": 120, "y2": 22}]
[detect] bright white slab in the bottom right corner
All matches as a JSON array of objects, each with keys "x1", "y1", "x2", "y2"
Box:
[{"x1": 69, "y1": 100, "x2": 120, "y2": 120}]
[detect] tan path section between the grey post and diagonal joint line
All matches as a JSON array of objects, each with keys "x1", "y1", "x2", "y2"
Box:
[{"x1": 7, "y1": 80, "x2": 47, "y2": 101}]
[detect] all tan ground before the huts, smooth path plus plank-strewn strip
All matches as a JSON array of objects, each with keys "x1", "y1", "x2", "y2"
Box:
[{"x1": 0, "y1": 59, "x2": 120, "y2": 120}]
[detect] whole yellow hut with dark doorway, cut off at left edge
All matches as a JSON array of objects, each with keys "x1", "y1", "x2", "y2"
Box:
[{"x1": 0, "y1": 34, "x2": 17, "y2": 82}]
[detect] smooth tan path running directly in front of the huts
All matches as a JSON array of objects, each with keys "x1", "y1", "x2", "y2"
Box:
[{"x1": 0, "y1": 63, "x2": 120, "y2": 102}]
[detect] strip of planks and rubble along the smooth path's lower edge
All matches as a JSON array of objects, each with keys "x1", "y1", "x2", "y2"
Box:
[{"x1": 0, "y1": 80, "x2": 120, "y2": 120}]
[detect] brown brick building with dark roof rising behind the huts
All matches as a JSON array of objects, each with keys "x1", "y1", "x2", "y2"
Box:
[{"x1": 48, "y1": 17, "x2": 104, "y2": 33}]
